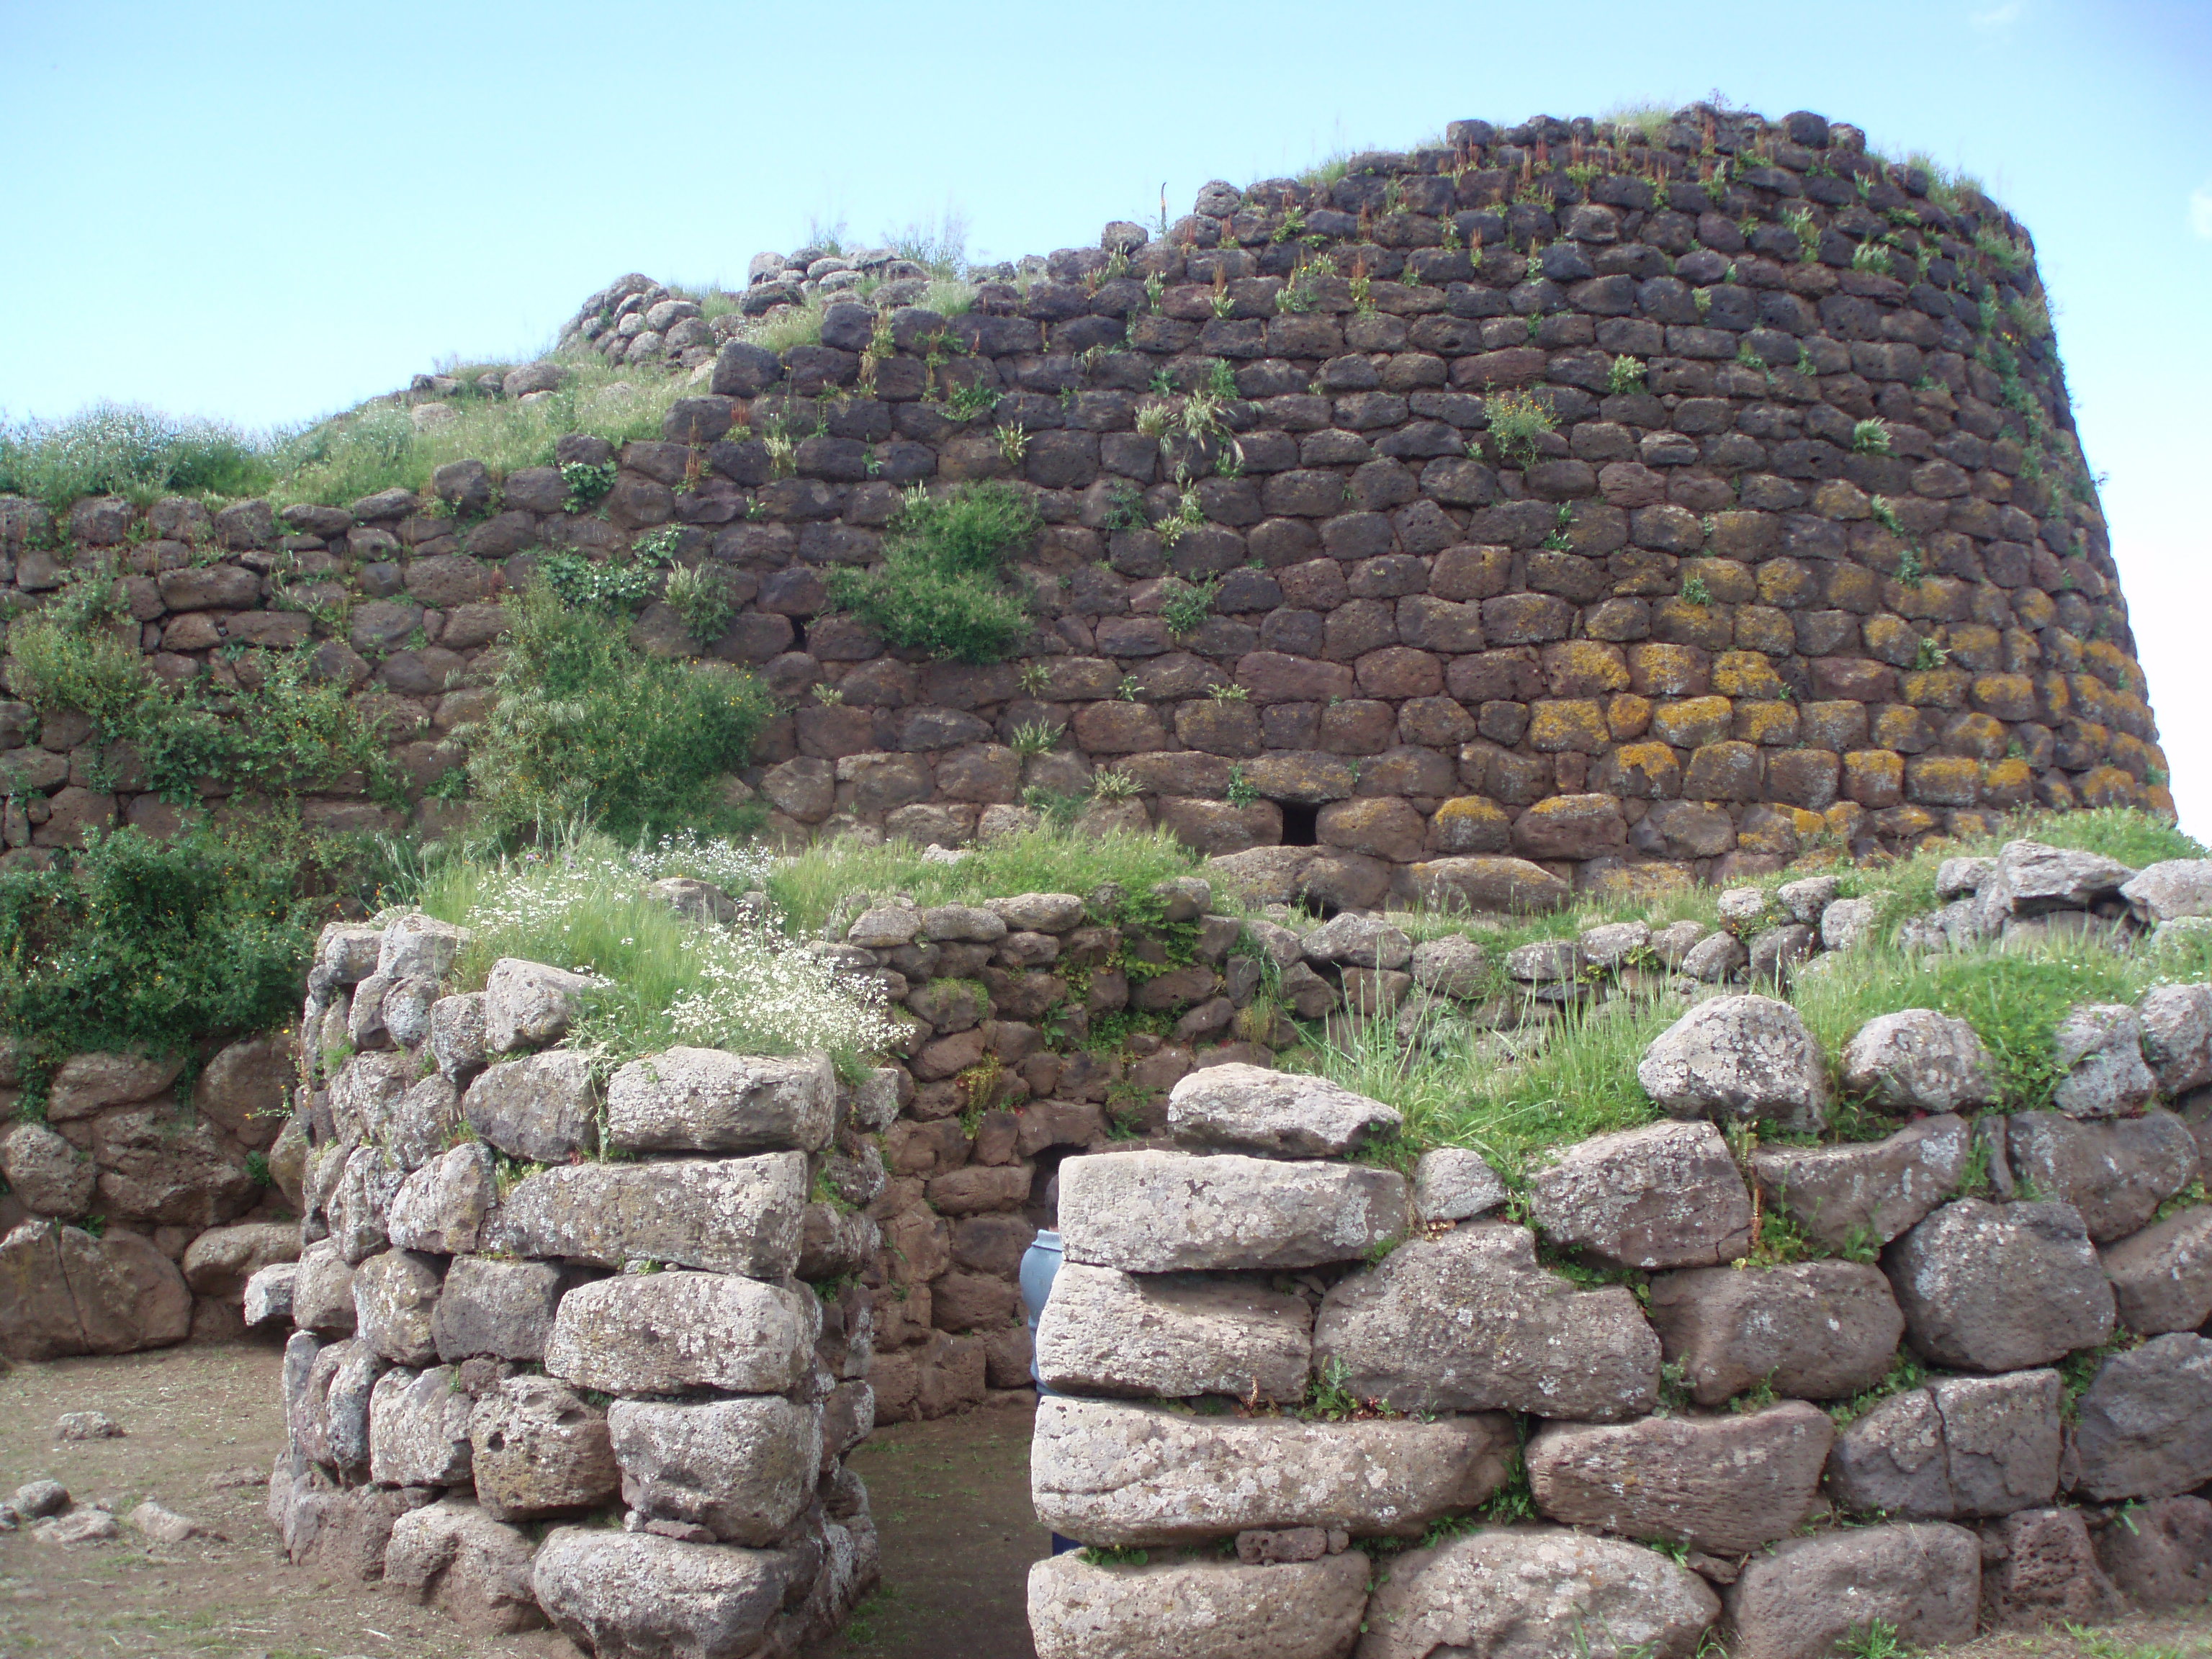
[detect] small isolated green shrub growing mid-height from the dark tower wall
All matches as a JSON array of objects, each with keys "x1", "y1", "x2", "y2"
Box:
[{"x1": 830, "y1": 485, "x2": 1042, "y2": 664}]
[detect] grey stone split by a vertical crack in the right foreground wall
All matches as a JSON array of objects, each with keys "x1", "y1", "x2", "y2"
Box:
[{"x1": 1827, "y1": 1370, "x2": 2064, "y2": 1519}]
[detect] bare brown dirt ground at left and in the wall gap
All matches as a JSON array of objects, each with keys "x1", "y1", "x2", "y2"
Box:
[{"x1": 0, "y1": 1343, "x2": 2212, "y2": 1659}]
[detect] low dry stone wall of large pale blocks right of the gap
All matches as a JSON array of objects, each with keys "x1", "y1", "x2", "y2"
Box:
[{"x1": 1028, "y1": 842, "x2": 2212, "y2": 1659}]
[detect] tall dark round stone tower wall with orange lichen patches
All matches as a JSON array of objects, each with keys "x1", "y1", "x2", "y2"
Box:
[{"x1": 0, "y1": 109, "x2": 2170, "y2": 907}]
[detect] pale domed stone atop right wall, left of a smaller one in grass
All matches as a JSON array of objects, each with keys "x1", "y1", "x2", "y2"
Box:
[{"x1": 1637, "y1": 995, "x2": 1827, "y2": 1128}]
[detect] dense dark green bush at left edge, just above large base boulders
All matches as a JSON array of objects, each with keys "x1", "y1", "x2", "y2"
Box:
[{"x1": 0, "y1": 830, "x2": 320, "y2": 1077}]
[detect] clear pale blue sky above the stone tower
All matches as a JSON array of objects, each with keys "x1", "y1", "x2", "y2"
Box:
[{"x1": 0, "y1": 0, "x2": 2212, "y2": 836}]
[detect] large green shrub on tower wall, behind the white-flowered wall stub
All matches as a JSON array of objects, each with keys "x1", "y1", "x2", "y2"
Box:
[{"x1": 469, "y1": 582, "x2": 770, "y2": 838}]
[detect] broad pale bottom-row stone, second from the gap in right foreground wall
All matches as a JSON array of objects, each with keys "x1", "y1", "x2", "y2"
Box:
[{"x1": 1356, "y1": 1527, "x2": 1716, "y2": 1659}]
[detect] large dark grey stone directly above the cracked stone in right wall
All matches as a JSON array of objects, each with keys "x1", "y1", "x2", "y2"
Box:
[{"x1": 1882, "y1": 1199, "x2": 2113, "y2": 1372}]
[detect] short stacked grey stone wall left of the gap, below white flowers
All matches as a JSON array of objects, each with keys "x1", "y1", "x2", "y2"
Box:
[{"x1": 263, "y1": 916, "x2": 887, "y2": 1659}]
